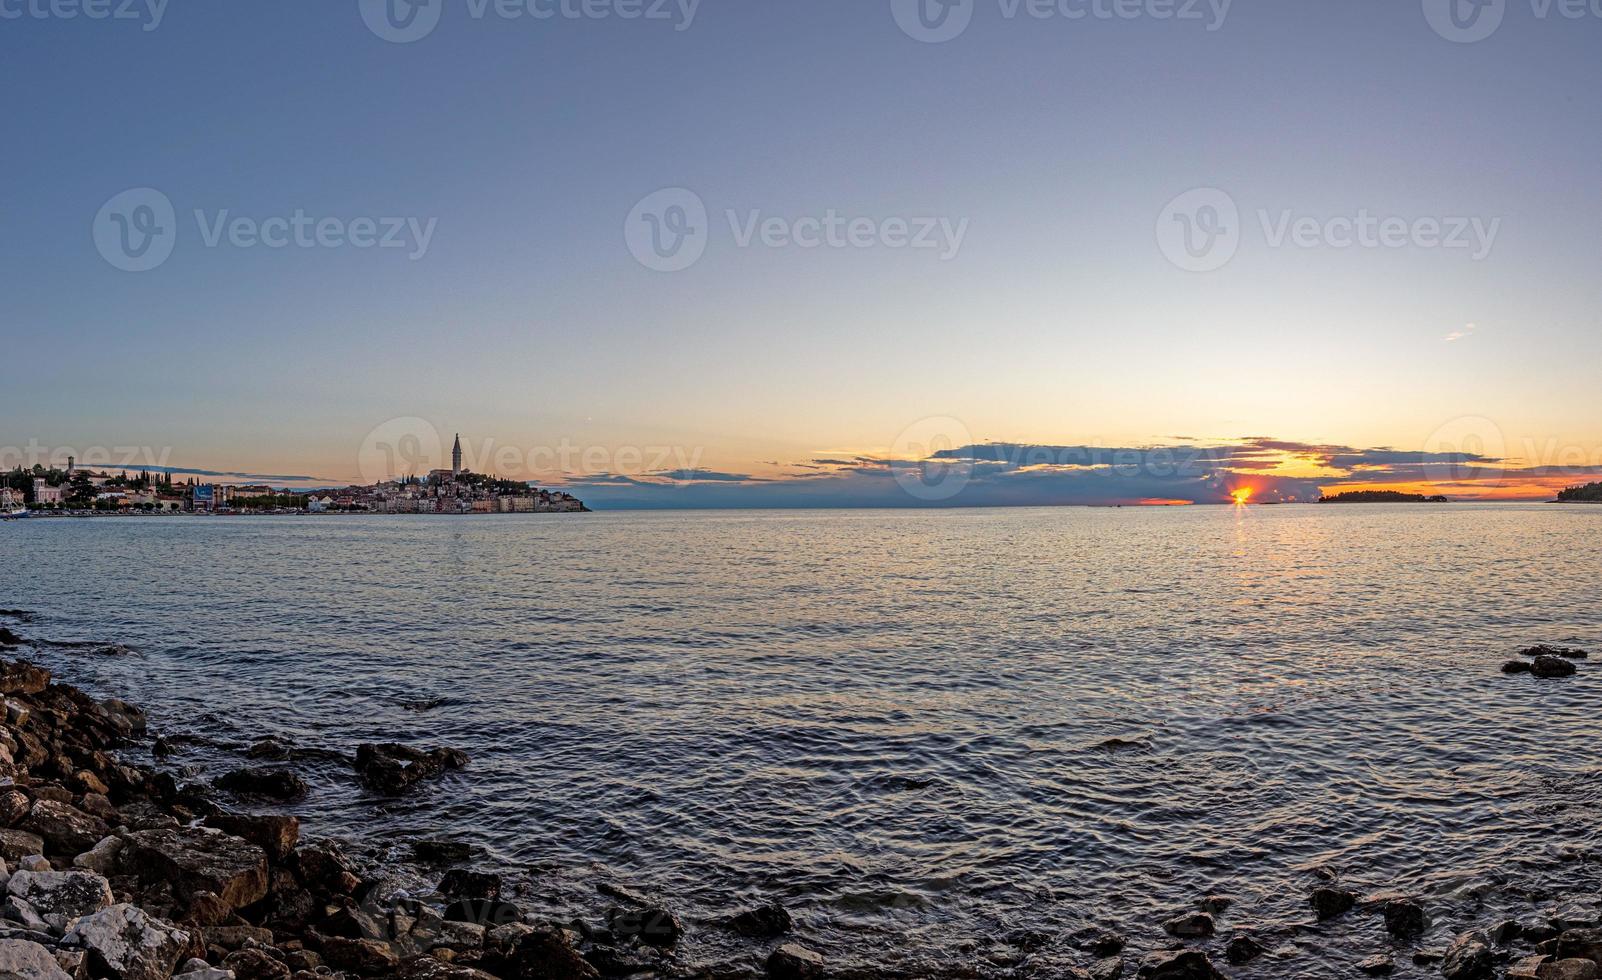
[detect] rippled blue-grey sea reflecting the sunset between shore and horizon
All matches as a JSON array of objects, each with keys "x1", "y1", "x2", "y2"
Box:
[{"x1": 0, "y1": 504, "x2": 1602, "y2": 977}]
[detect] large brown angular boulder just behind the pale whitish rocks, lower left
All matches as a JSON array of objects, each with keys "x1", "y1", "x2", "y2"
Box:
[{"x1": 125, "y1": 826, "x2": 268, "y2": 908}]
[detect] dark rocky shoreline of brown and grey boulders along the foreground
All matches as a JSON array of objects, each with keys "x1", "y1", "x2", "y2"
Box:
[{"x1": 0, "y1": 610, "x2": 1602, "y2": 980}]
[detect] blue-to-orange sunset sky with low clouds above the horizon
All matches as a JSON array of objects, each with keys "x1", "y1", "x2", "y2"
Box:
[{"x1": 0, "y1": 0, "x2": 1602, "y2": 508}]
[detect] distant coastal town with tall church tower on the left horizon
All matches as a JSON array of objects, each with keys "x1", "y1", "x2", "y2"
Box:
[{"x1": 0, "y1": 437, "x2": 590, "y2": 519}]
